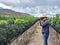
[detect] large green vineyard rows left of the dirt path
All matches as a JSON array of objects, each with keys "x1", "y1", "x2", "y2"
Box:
[{"x1": 0, "y1": 15, "x2": 37, "y2": 45}]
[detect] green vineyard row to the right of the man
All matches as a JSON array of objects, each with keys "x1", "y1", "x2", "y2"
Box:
[{"x1": 49, "y1": 14, "x2": 60, "y2": 34}]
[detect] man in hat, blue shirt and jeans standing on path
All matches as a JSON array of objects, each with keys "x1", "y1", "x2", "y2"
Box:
[{"x1": 40, "y1": 15, "x2": 50, "y2": 45}]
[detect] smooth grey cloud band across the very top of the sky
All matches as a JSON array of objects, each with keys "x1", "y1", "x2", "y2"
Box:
[{"x1": 0, "y1": 0, "x2": 60, "y2": 7}]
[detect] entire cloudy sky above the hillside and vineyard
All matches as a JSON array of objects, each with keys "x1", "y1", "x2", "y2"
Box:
[{"x1": 0, "y1": 0, "x2": 60, "y2": 17}]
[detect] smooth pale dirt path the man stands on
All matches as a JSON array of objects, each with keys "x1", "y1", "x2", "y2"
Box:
[{"x1": 27, "y1": 21, "x2": 58, "y2": 45}]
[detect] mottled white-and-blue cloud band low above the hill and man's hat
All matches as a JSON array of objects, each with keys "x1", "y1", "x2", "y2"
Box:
[{"x1": 14, "y1": 6, "x2": 60, "y2": 17}]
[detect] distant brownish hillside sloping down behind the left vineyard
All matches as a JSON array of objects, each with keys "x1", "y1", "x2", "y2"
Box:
[{"x1": 0, "y1": 9, "x2": 29, "y2": 16}]
